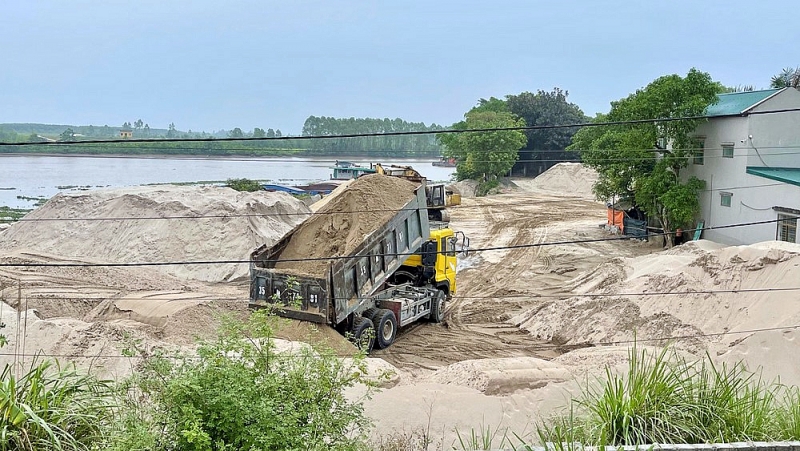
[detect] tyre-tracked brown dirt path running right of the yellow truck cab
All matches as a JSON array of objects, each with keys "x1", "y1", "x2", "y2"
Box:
[{"x1": 374, "y1": 191, "x2": 653, "y2": 375}]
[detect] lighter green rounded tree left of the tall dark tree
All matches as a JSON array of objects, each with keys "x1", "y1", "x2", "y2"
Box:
[{"x1": 437, "y1": 99, "x2": 525, "y2": 191}]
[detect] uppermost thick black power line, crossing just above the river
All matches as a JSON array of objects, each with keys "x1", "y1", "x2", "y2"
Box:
[{"x1": 0, "y1": 108, "x2": 800, "y2": 147}]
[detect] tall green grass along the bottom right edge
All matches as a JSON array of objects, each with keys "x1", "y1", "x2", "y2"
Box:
[{"x1": 537, "y1": 346, "x2": 800, "y2": 449}]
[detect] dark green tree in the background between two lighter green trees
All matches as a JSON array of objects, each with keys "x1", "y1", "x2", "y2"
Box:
[{"x1": 506, "y1": 88, "x2": 587, "y2": 175}]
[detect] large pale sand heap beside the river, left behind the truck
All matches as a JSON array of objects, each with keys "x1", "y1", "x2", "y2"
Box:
[{"x1": 0, "y1": 186, "x2": 310, "y2": 282}]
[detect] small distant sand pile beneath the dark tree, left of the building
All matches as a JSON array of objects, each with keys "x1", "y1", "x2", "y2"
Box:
[{"x1": 513, "y1": 163, "x2": 598, "y2": 199}]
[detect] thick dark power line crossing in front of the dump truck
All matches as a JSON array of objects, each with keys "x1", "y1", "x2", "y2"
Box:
[{"x1": 0, "y1": 219, "x2": 786, "y2": 268}]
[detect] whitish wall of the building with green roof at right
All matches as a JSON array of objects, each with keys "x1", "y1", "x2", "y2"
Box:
[{"x1": 682, "y1": 100, "x2": 800, "y2": 245}]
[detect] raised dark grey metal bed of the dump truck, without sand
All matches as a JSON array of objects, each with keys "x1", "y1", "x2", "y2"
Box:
[{"x1": 250, "y1": 175, "x2": 430, "y2": 325}]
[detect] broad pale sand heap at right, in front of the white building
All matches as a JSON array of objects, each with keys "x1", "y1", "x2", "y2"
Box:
[{"x1": 512, "y1": 241, "x2": 800, "y2": 383}]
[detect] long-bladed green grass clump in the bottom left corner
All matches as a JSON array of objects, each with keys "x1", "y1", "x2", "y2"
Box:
[{"x1": 0, "y1": 360, "x2": 114, "y2": 451}]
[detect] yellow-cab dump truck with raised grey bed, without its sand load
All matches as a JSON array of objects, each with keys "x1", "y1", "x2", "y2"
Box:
[{"x1": 250, "y1": 182, "x2": 469, "y2": 351}]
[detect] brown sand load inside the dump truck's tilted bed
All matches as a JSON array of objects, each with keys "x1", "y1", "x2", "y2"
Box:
[{"x1": 275, "y1": 174, "x2": 419, "y2": 276}]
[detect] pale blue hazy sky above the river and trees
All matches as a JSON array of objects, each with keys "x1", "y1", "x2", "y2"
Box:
[{"x1": 0, "y1": 0, "x2": 800, "y2": 134}]
